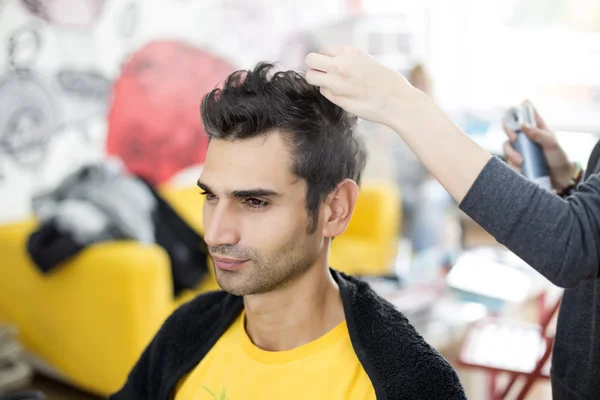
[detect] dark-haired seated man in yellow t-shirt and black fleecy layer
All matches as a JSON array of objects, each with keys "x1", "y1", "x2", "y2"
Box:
[{"x1": 112, "y1": 64, "x2": 465, "y2": 400}]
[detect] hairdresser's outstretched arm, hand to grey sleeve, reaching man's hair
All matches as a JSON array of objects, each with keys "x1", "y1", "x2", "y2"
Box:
[{"x1": 306, "y1": 47, "x2": 600, "y2": 287}]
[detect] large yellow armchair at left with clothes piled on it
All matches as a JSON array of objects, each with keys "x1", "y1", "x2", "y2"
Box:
[{"x1": 0, "y1": 220, "x2": 173, "y2": 395}]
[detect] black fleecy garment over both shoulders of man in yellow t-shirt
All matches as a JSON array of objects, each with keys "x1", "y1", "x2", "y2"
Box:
[{"x1": 109, "y1": 270, "x2": 466, "y2": 400}]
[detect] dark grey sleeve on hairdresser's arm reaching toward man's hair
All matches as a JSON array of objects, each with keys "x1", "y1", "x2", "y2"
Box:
[{"x1": 460, "y1": 157, "x2": 600, "y2": 287}]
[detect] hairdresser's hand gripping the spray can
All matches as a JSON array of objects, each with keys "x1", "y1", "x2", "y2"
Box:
[{"x1": 504, "y1": 101, "x2": 575, "y2": 190}]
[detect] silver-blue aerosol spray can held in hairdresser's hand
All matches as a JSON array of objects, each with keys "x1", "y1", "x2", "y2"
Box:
[{"x1": 504, "y1": 103, "x2": 552, "y2": 191}]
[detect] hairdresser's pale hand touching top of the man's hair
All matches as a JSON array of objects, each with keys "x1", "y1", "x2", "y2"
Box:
[{"x1": 305, "y1": 46, "x2": 424, "y2": 126}]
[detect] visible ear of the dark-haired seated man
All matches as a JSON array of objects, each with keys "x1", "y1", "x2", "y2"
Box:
[{"x1": 323, "y1": 179, "x2": 358, "y2": 238}]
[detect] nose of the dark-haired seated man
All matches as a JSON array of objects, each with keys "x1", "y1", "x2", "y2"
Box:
[{"x1": 204, "y1": 202, "x2": 240, "y2": 247}]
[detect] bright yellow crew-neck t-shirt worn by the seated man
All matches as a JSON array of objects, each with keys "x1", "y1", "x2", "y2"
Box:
[{"x1": 175, "y1": 313, "x2": 375, "y2": 400}]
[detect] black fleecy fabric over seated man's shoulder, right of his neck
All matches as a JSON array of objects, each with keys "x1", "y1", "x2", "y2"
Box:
[{"x1": 342, "y1": 274, "x2": 464, "y2": 399}]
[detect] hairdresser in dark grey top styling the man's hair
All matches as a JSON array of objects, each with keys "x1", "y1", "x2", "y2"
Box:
[{"x1": 306, "y1": 46, "x2": 600, "y2": 400}]
